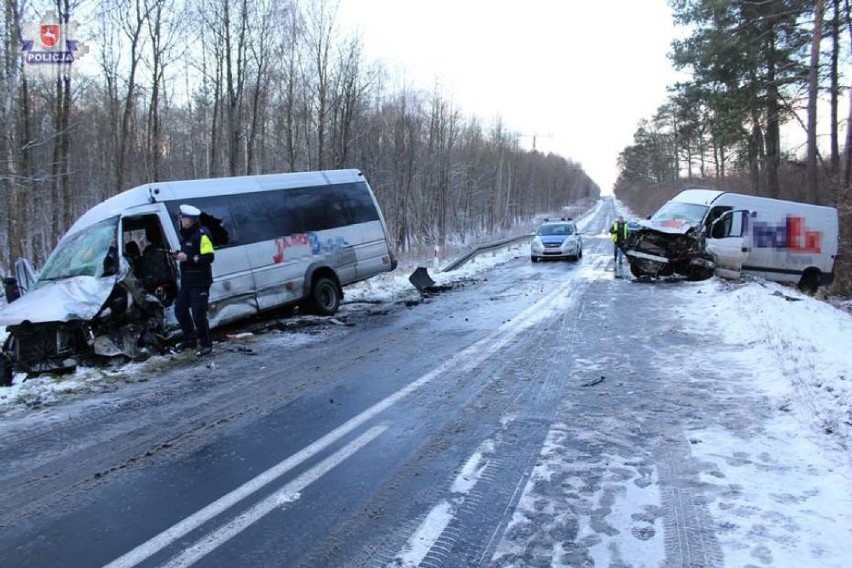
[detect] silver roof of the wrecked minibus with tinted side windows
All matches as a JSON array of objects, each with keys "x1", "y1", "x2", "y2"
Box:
[{"x1": 66, "y1": 169, "x2": 363, "y2": 236}]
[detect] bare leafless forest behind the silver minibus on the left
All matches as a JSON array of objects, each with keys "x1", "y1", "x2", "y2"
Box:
[{"x1": 0, "y1": 0, "x2": 600, "y2": 273}]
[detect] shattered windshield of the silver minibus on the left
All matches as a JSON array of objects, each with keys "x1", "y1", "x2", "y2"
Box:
[{"x1": 36, "y1": 217, "x2": 118, "y2": 286}]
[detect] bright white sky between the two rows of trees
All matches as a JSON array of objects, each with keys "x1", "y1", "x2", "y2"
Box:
[{"x1": 338, "y1": 0, "x2": 676, "y2": 194}]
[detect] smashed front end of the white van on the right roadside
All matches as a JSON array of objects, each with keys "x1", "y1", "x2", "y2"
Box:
[{"x1": 624, "y1": 219, "x2": 714, "y2": 280}]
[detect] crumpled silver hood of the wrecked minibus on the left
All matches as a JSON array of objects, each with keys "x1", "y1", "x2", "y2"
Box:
[{"x1": 0, "y1": 276, "x2": 116, "y2": 326}]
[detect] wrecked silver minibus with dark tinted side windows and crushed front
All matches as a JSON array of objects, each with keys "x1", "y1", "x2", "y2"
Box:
[{"x1": 0, "y1": 170, "x2": 396, "y2": 383}]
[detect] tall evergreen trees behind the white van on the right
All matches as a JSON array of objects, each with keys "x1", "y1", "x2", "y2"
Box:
[{"x1": 614, "y1": 0, "x2": 852, "y2": 296}]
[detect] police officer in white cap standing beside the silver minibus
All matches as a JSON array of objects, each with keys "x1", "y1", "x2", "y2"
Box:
[{"x1": 175, "y1": 205, "x2": 214, "y2": 357}]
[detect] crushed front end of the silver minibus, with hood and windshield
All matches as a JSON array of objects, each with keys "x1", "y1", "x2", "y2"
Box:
[{"x1": 0, "y1": 220, "x2": 165, "y2": 382}]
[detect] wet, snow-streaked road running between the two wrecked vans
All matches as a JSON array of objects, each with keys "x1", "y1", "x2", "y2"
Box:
[{"x1": 0, "y1": 203, "x2": 852, "y2": 568}]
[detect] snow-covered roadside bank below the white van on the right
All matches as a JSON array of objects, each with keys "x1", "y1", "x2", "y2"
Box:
[{"x1": 678, "y1": 279, "x2": 852, "y2": 448}]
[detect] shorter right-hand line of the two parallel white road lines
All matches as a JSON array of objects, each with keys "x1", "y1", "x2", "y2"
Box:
[{"x1": 163, "y1": 425, "x2": 387, "y2": 568}]
